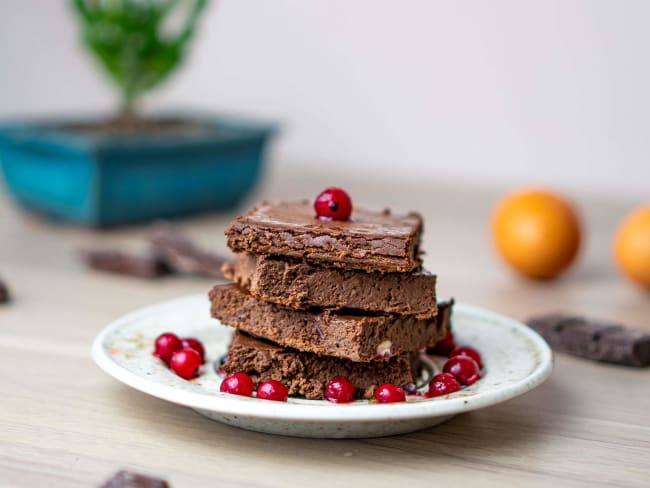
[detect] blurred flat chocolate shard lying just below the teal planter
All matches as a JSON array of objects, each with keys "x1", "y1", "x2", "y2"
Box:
[{"x1": 82, "y1": 249, "x2": 171, "y2": 279}]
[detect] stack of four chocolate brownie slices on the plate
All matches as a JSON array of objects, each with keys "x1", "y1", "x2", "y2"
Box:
[{"x1": 210, "y1": 202, "x2": 447, "y2": 399}]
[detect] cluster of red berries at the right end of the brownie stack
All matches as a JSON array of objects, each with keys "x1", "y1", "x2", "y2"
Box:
[{"x1": 425, "y1": 332, "x2": 483, "y2": 398}]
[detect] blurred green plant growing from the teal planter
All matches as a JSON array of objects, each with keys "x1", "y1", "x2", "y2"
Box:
[{"x1": 72, "y1": 0, "x2": 207, "y2": 115}]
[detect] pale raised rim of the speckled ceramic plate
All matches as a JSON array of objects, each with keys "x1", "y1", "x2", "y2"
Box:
[{"x1": 92, "y1": 295, "x2": 553, "y2": 422}]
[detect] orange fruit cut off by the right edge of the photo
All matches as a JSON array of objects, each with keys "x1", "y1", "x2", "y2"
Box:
[{"x1": 614, "y1": 206, "x2": 650, "y2": 290}]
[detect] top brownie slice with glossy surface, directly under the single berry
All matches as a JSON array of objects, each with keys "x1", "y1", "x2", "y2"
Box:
[{"x1": 226, "y1": 201, "x2": 422, "y2": 272}]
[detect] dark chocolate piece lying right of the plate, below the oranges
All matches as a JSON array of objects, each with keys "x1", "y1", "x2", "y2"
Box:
[{"x1": 528, "y1": 314, "x2": 650, "y2": 367}]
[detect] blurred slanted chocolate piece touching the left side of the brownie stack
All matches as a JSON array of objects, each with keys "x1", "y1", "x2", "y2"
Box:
[{"x1": 149, "y1": 223, "x2": 230, "y2": 279}]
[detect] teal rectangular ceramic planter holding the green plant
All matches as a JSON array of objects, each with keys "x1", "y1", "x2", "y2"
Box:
[{"x1": 0, "y1": 116, "x2": 274, "y2": 227}]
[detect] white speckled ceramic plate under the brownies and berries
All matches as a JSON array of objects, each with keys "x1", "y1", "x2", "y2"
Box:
[{"x1": 92, "y1": 295, "x2": 552, "y2": 438}]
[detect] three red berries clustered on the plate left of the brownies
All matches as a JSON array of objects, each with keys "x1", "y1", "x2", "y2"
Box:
[{"x1": 153, "y1": 332, "x2": 205, "y2": 380}]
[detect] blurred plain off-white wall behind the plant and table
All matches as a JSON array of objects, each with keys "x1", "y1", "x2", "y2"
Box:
[{"x1": 0, "y1": 0, "x2": 650, "y2": 199}]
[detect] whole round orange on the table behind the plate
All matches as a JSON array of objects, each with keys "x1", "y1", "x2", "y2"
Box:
[{"x1": 492, "y1": 190, "x2": 580, "y2": 280}]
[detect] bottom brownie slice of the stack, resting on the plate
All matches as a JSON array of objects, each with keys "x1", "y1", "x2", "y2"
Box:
[{"x1": 222, "y1": 331, "x2": 419, "y2": 400}]
